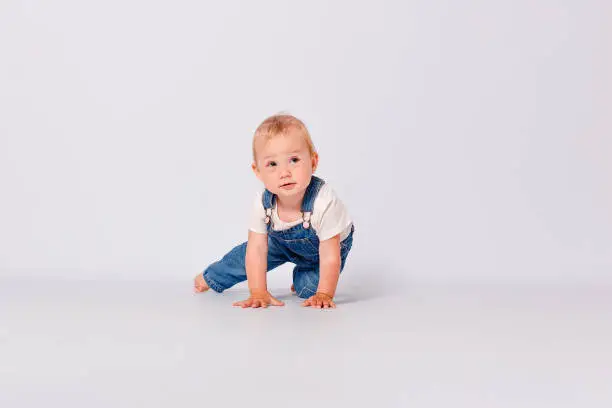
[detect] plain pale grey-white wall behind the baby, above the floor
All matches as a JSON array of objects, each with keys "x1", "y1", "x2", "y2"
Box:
[{"x1": 0, "y1": 0, "x2": 612, "y2": 283}]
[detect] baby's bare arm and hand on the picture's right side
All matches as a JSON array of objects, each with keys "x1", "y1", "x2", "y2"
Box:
[{"x1": 302, "y1": 234, "x2": 341, "y2": 308}]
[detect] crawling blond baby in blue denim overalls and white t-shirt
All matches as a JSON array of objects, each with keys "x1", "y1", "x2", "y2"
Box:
[{"x1": 195, "y1": 115, "x2": 355, "y2": 308}]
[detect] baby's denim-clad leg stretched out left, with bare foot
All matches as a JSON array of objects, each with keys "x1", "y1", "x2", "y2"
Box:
[{"x1": 195, "y1": 240, "x2": 288, "y2": 293}]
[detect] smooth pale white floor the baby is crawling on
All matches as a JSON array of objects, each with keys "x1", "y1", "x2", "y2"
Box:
[{"x1": 0, "y1": 279, "x2": 612, "y2": 408}]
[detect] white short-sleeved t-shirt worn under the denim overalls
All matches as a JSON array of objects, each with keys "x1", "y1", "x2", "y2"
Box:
[{"x1": 249, "y1": 183, "x2": 353, "y2": 241}]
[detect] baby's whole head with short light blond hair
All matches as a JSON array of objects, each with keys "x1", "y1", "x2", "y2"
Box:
[{"x1": 252, "y1": 114, "x2": 319, "y2": 197}]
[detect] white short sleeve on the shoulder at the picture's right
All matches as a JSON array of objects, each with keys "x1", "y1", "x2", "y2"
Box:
[{"x1": 313, "y1": 187, "x2": 352, "y2": 241}]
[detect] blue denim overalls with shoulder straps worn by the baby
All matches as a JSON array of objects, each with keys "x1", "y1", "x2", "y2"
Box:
[{"x1": 203, "y1": 176, "x2": 355, "y2": 299}]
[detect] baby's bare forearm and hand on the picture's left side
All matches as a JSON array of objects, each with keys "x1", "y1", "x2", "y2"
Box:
[{"x1": 234, "y1": 231, "x2": 284, "y2": 308}]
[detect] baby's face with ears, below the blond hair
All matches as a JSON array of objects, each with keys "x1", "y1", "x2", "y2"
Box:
[{"x1": 253, "y1": 132, "x2": 318, "y2": 198}]
